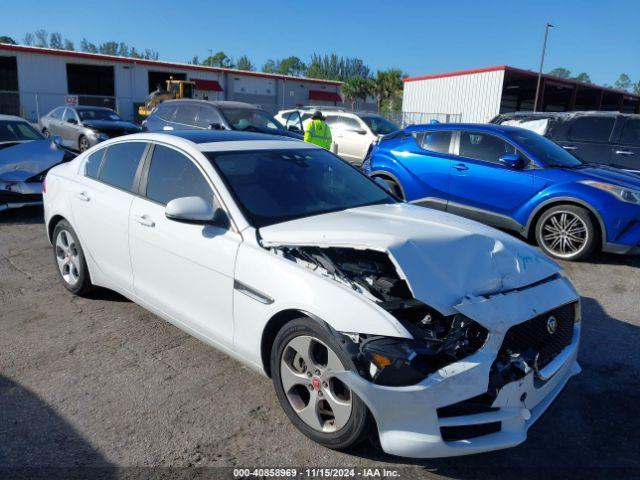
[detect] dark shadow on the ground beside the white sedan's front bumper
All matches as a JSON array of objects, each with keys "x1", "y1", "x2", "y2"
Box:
[{"x1": 351, "y1": 297, "x2": 640, "y2": 479}]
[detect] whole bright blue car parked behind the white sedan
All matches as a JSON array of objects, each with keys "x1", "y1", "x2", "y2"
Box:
[{"x1": 363, "y1": 124, "x2": 640, "y2": 260}]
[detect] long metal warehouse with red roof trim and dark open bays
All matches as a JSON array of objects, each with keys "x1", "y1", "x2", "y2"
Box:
[{"x1": 0, "y1": 44, "x2": 342, "y2": 121}]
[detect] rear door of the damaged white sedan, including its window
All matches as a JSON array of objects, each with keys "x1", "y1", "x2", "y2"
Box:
[{"x1": 70, "y1": 142, "x2": 148, "y2": 292}]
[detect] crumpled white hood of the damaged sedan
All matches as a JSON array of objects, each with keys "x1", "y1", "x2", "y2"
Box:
[{"x1": 260, "y1": 204, "x2": 561, "y2": 315}]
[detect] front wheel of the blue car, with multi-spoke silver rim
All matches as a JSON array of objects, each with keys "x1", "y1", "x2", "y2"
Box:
[{"x1": 535, "y1": 205, "x2": 598, "y2": 261}]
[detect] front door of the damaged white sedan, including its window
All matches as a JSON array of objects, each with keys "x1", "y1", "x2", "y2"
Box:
[{"x1": 129, "y1": 144, "x2": 242, "y2": 347}]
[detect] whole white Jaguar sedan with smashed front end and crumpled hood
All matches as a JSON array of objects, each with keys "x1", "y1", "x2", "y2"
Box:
[{"x1": 44, "y1": 131, "x2": 580, "y2": 457}]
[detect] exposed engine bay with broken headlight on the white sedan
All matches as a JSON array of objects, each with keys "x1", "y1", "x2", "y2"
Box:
[{"x1": 274, "y1": 247, "x2": 488, "y2": 386}]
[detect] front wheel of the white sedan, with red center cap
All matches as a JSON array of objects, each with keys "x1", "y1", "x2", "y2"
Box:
[{"x1": 271, "y1": 317, "x2": 370, "y2": 450}]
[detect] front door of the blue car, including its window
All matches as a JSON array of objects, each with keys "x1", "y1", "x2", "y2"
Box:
[{"x1": 447, "y1": 131, "x2": 534, "y2": 229}]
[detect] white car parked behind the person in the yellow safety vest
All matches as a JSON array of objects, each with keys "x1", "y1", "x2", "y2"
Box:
[{"x1": 276, "y1": 107, "x2": 400, "y2": 166}]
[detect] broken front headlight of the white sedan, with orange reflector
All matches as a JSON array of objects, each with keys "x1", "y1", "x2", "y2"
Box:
[{"x1": 350, "y1": 315, "x2": 489, "y2": 387}]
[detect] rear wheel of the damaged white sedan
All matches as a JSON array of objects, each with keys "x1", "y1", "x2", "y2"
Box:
[{"x1": 53, "y1": 220, "x2": 93, "y2": 296}]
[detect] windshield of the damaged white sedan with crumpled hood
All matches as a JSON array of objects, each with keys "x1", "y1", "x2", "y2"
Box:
[{"x1": 206, "y1": 148, "x2": 396, "y2": 228}]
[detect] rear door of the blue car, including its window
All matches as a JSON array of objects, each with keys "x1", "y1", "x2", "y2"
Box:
[{"x1": 394, "y1": 130, "x2": 453, "y2": 210}]
